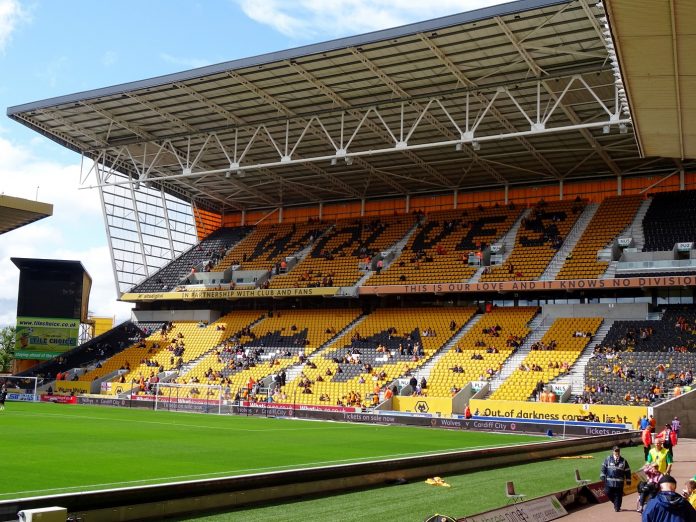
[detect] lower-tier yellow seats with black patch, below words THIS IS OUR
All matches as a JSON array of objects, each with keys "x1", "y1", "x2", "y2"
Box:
[{"x1": 282, "y1": 307, "x2": 475, "y2": 406}]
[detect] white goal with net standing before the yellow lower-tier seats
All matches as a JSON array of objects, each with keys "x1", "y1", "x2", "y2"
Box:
[{"x1": 155, "y1": 382, "x2": 223, "y2": 414}]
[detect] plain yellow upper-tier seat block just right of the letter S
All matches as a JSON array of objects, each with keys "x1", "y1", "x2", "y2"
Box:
[{"x1": 556, "y1": 196, "x2": 642, "y2": 279}]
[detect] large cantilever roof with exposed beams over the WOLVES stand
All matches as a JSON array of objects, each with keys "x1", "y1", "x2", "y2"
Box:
[{"x1": 7, "y1": 0, "x2": 688, "y2": 212}]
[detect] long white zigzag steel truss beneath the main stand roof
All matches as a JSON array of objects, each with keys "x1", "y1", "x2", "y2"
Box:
[{"x1": 87, "y1": 74, "x2": 631, "y2": 189}]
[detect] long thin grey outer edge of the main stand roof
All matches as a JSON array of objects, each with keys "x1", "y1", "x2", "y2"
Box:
[{"x1": 7, "y1": 0, "x2": 570, "y2": 117}]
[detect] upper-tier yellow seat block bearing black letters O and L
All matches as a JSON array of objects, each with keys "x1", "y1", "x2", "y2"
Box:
[{"x1": 270, "y1": 214, "x2": 414, "y2": 288}]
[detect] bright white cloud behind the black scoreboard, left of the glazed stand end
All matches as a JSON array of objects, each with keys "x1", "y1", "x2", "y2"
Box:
[{"x1": 0, "y1": 135, "x2": 131, "y2": 326}]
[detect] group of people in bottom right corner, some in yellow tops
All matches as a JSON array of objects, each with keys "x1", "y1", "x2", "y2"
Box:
[{"x1": 600, "y1": 415, "x2": 696, "y2": 522}]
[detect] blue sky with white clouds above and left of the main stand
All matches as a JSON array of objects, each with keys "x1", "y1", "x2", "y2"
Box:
[{"x1": 0, "y1": 0, "x2": 503, "y2": 326}]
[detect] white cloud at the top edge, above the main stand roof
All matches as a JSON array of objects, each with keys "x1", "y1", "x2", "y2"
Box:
[{"x1": 237, "y1": 0, "x2": 503, "y2": 40}]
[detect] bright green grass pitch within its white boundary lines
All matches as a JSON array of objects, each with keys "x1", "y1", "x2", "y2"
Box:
[{"x1": 0, "y1": 402, "x2": 543, "y2": 500}]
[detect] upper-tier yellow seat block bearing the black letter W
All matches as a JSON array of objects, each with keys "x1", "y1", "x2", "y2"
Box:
[{"x1": 216, "y1": 223, "x2": 327, "y2": 270}]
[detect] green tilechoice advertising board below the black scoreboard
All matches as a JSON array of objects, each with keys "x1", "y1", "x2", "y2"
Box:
[{"x1": 15, "y1": 317, "x2": 80, "y2": 360}]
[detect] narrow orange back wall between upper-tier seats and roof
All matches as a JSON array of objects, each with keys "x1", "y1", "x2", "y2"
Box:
[{"x1": 211, "y1": 172, "x2": 696, "y2": 232}]
